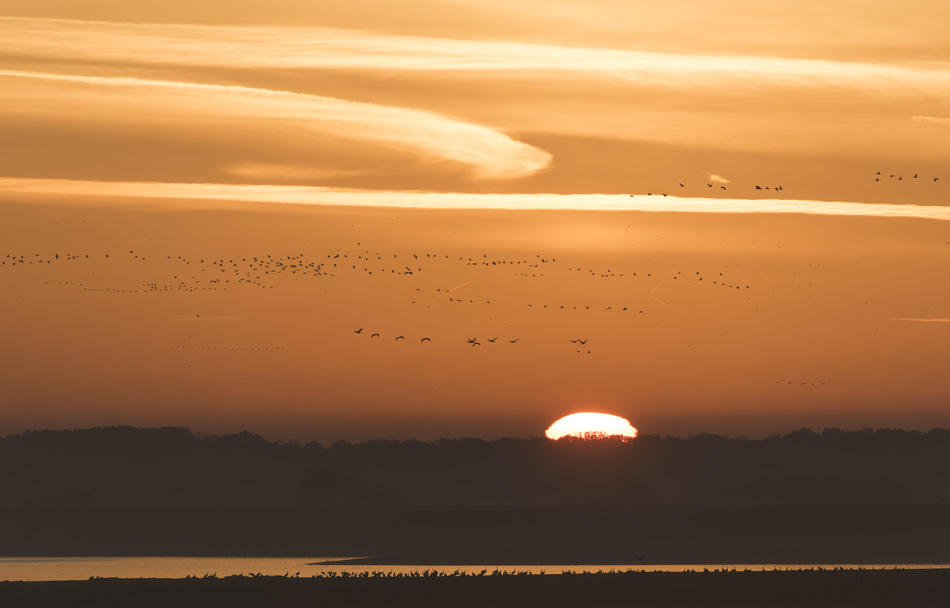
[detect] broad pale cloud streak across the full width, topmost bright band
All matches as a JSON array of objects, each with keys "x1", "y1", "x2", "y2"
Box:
[{"x1": 0, "y1": 17, "x2": 950, "y2": 93}]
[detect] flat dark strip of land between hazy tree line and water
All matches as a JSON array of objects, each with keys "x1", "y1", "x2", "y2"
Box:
[{"x1": 0, "y1": 504, "x2": 950, "y2": 564}]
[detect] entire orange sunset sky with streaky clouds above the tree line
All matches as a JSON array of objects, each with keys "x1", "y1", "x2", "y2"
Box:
[{"x1": 0, "y1": 0, "x2": 950, "y2": 441}]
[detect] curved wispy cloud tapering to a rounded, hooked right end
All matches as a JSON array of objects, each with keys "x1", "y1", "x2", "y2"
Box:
[{"x1": 0, "y1": 70, "x2": 551, "y2": 178}]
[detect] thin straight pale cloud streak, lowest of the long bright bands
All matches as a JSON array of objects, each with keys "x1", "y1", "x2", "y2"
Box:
[{"x1": 0, "y1": 177, "x2": 950, "y2": 221}]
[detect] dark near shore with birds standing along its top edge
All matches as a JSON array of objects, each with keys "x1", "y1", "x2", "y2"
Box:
[{"x1": 0, "y1": 570, "x2": 950, "y2": 608}]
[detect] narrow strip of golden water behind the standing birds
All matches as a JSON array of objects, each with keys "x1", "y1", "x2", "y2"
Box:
[{"x1": 0, "y1": 557, "x2": 950, "y2": 581}]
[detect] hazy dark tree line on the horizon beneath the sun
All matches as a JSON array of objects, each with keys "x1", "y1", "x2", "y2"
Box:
[{"x1": 0, "y1": 427, "x2": 950, "y2": 509}]
